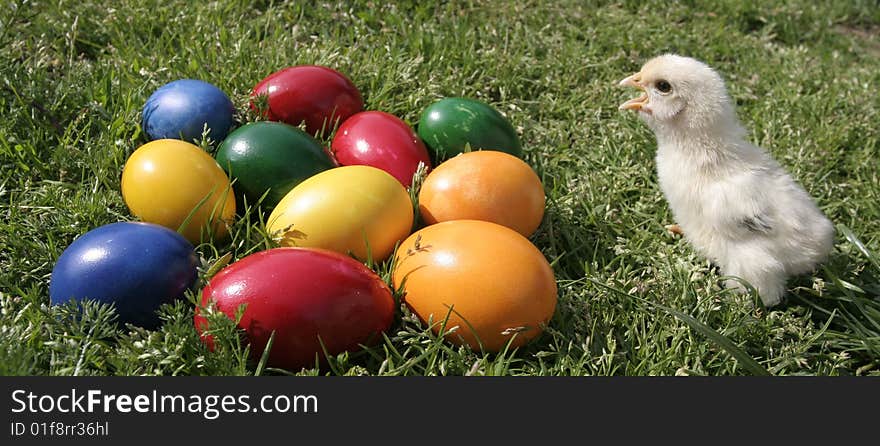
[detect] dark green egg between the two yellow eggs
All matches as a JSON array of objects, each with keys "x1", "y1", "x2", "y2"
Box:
[{"x1": 217, "y1": 121, "x2": 333, "y2": 209}]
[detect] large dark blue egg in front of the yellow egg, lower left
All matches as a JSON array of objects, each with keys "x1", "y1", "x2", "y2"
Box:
[{"x1": 49, "y1": 222, "x2": 198, "y2": 328}]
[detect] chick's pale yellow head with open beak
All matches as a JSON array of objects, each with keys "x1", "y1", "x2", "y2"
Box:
[{"x1": 620, "y1": 54, "x2": 735, "y2": 130}]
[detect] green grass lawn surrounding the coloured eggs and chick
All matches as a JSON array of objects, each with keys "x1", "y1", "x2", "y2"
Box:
[{"x1": 0, "y1": 0, "x2": 880, "y2": 375}]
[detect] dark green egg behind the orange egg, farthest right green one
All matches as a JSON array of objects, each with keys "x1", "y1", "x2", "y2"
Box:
[{"x1": 418, "y1": 98, "x2": 522, "y2": 162}]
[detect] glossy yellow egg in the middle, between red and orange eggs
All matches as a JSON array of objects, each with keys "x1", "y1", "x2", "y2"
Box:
[{"x1": 267, "y1": 166, "x2": 413, "y2": 260}]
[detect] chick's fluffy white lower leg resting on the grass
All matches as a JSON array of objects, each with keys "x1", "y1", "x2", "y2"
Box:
[{"x1": 722, "y1": 250, "x2": 786, "y2": 307}]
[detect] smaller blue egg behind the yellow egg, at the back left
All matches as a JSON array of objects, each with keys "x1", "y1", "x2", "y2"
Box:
[{"x1": 141, "y1": 79, "x2": 235, "y2": 142}]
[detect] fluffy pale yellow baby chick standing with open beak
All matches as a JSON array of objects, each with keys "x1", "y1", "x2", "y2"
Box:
[{"x1": 620, "y1": 54, "x2": 834, "y2": 307}]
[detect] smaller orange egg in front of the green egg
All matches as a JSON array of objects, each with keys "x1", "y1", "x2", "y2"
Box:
[{"x1": 419, "y1": 150, "x2": 545, "y2": 237}]
